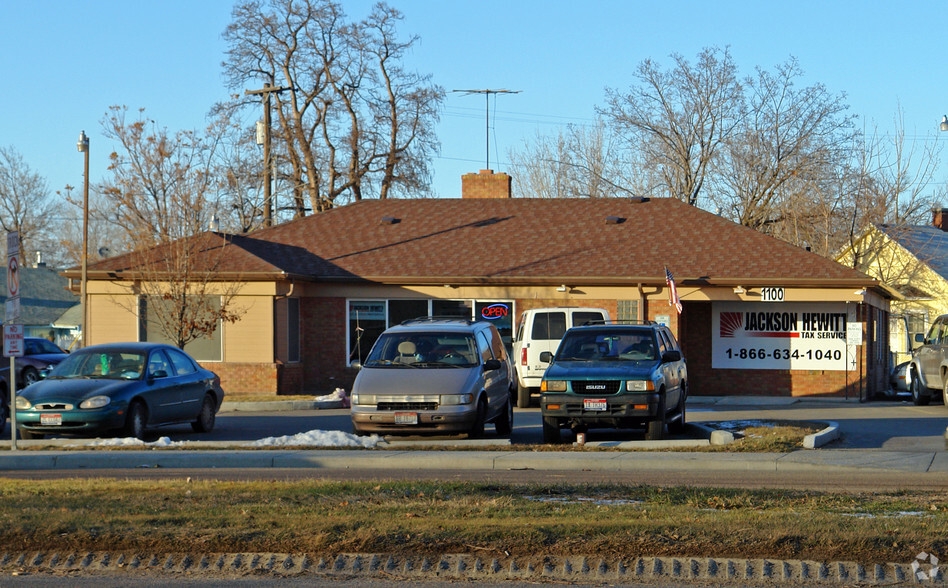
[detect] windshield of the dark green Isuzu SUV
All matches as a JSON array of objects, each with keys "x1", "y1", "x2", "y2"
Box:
[{"x1": 556, "y1": 329, "x2": 658, "y2": 361}]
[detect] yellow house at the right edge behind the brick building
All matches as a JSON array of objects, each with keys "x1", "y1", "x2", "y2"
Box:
[{"x1": 836, "y1": 208, "x2": 948, "y2": 366}]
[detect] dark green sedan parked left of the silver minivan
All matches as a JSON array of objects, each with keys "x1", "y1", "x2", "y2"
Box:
[{"x1": 16, "y1": 343, "x2": 224, "y2": 439}]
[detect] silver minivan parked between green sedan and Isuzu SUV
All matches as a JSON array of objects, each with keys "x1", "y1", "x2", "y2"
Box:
[{"x1": 351, "y1": 317, "x2": 513, "y2": 437}]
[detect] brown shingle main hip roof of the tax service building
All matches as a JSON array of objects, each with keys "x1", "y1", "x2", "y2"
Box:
[{"x1": 78, "y1": 198, "x2": 872, "y2": 286}]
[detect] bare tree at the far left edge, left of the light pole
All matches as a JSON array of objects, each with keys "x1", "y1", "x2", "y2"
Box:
[{"x1": 0, "y1": 147, "x2": 55, "y2": 263}]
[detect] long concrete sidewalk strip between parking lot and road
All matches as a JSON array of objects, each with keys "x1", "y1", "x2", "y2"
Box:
[{"x1": 0, "y1": 444, "x2": 948, "y2": 474}]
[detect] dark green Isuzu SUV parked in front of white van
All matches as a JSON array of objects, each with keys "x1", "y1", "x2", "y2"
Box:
[{"x1": 540, "y1": 322, "x2": 688, "y2": 443}]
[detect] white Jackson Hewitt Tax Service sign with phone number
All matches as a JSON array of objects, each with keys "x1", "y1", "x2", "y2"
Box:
[{"x1": 712, "y1": 302, "x2": 847, "y2": 370}]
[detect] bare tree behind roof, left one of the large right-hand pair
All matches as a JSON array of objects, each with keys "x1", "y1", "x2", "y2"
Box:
[{"x1": 599, "y1": 48, "x2": 742, "y2": 206}]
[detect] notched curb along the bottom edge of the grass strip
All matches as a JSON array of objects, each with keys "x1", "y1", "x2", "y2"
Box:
[{"x1": 0, "y1": 552, "x2": 932, "y2": 586}]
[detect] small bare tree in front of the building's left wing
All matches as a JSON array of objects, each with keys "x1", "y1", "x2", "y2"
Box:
[{"x1": 98, "y1": 107, "x2": 242, "y2": 348}]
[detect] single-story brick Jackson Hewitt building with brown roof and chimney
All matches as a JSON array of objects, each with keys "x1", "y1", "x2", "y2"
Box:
[{"x1": 64, "y1": 170, "x2": 888, "y2": 396}]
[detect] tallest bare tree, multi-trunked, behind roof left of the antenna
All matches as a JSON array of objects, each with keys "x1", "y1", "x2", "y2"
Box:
[{"x1": 219, "y1": 0, "x2": 444, "y2": 216}]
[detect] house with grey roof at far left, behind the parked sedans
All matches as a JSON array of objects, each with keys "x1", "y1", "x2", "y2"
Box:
[{"x1": 0, "y1": 264, "x2": 81, "y2": 349}]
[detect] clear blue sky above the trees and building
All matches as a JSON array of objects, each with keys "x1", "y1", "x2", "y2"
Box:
[{"x1": 0, "y1": 0, "x2": 948, "y2": 209}]
